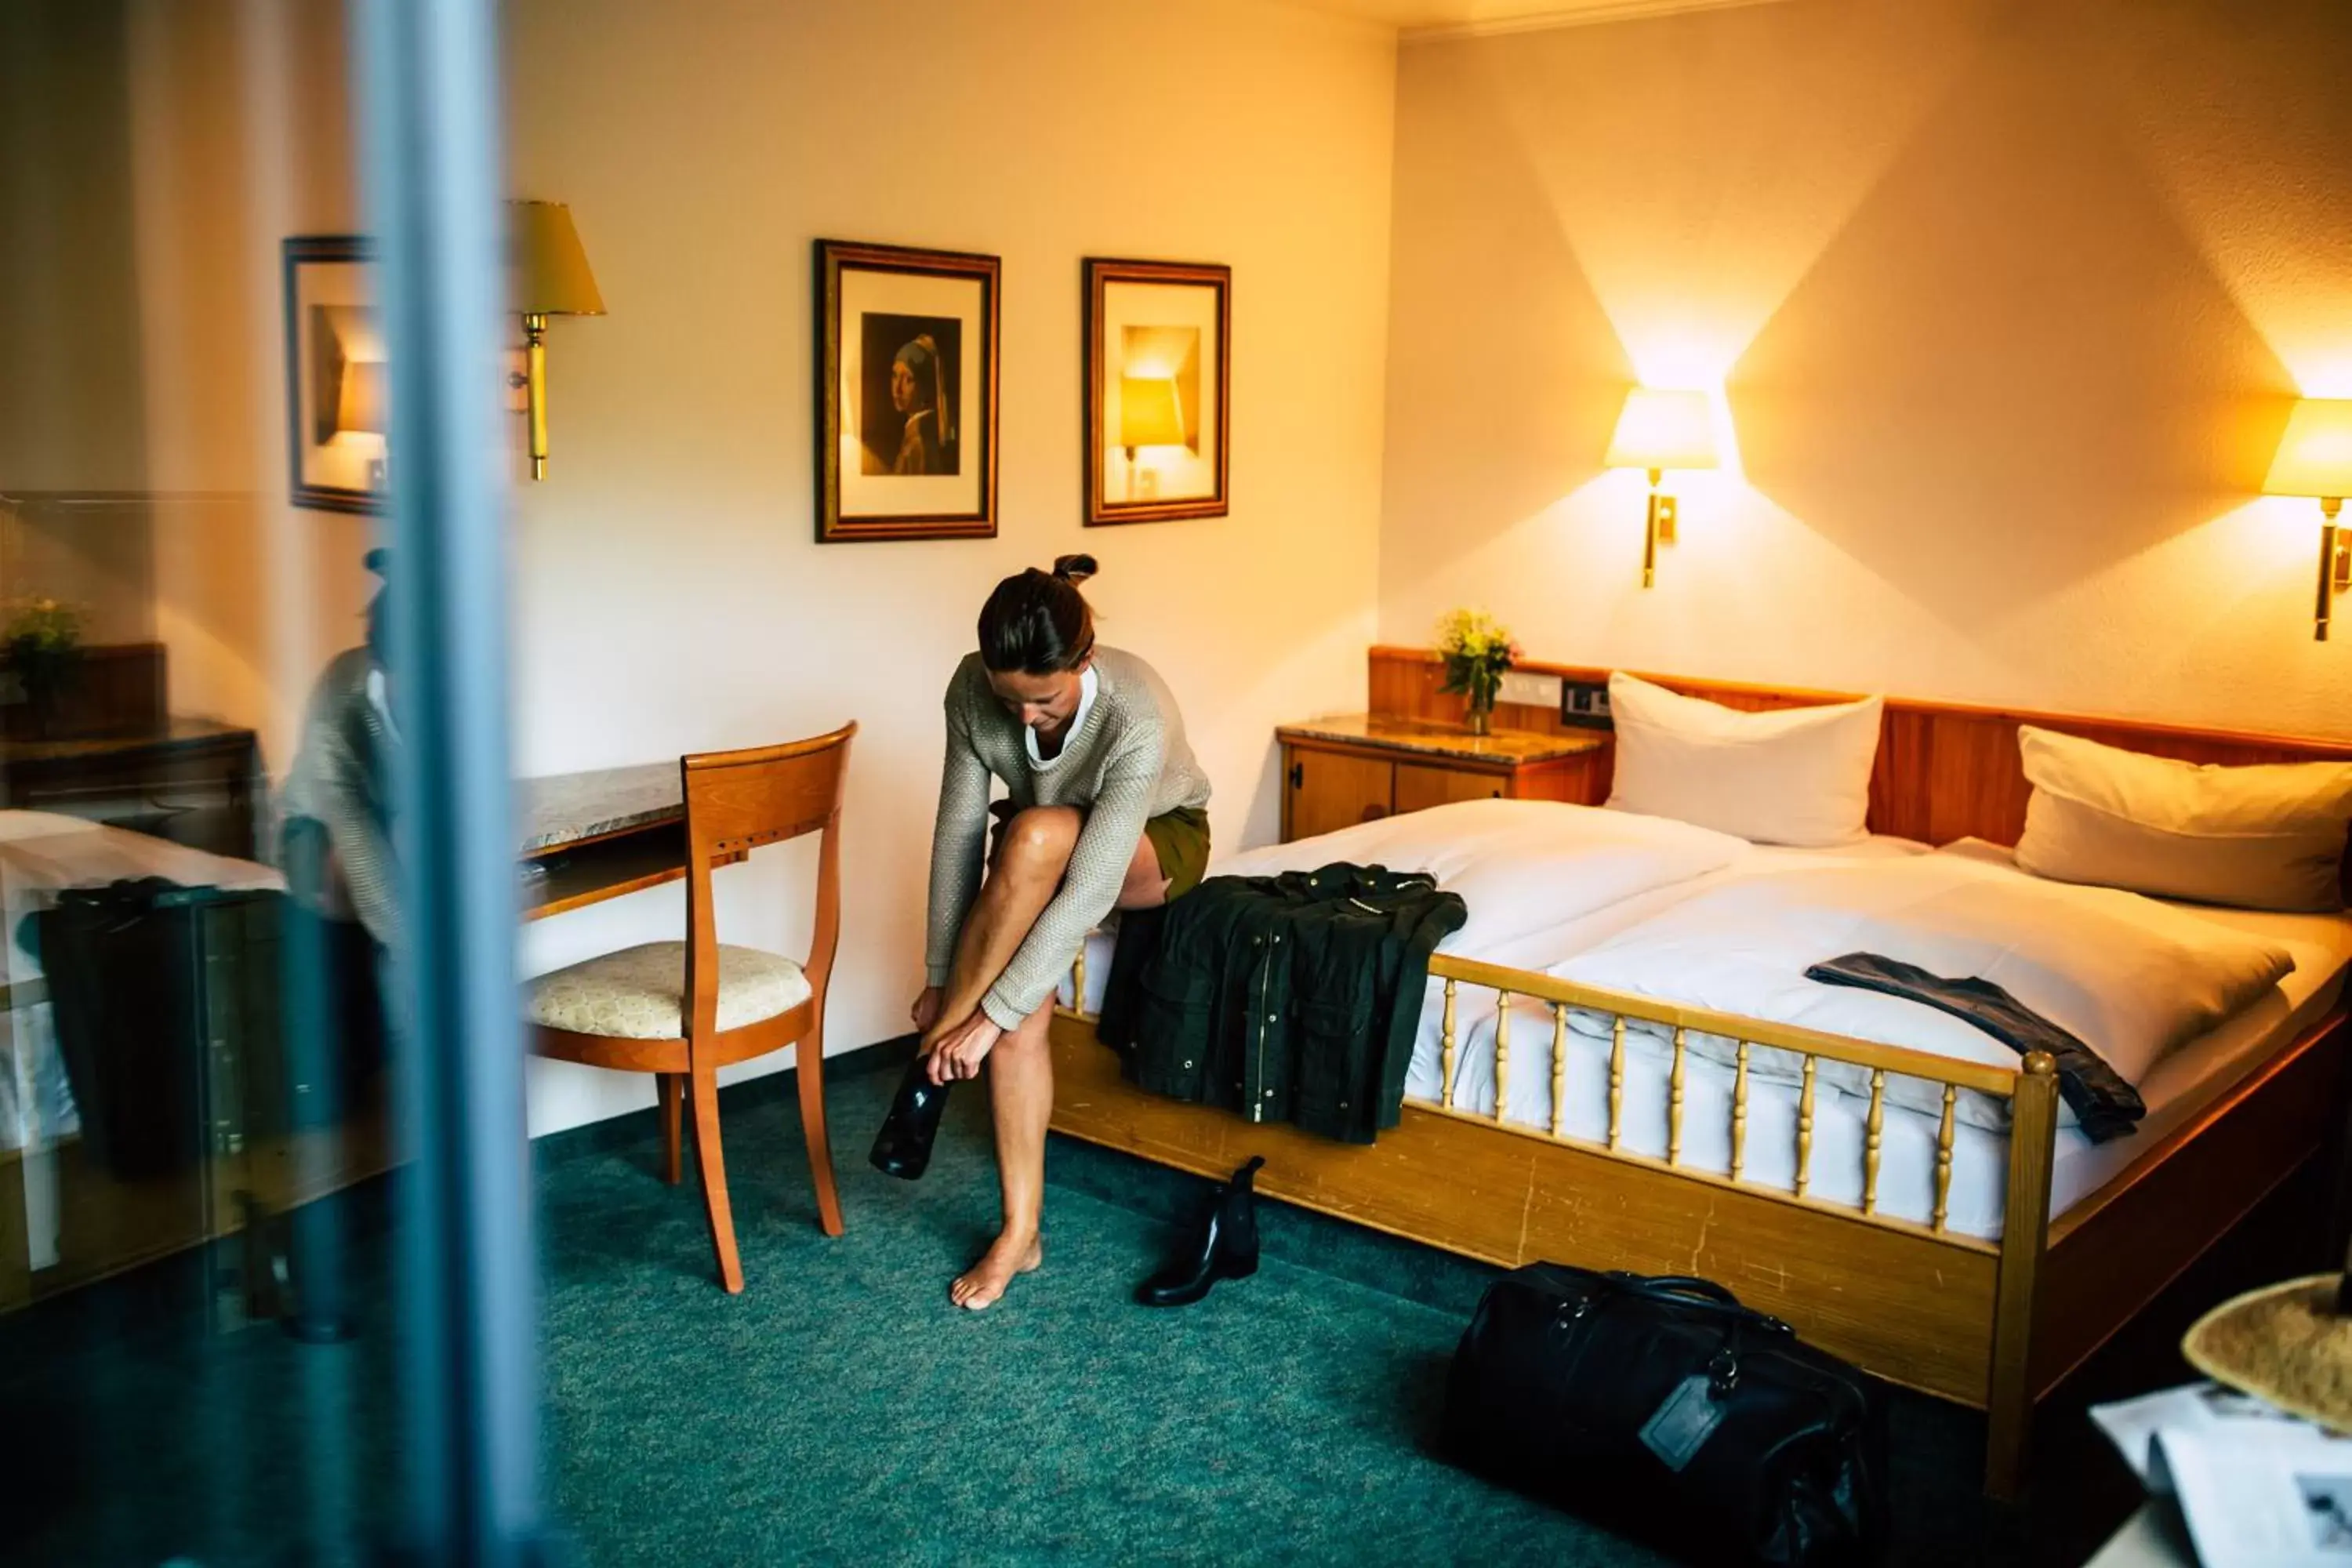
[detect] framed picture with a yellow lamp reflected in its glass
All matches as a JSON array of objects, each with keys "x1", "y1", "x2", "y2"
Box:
[{"x1": 1087, "y1": 256, "x2": 1232, "y2": 527}]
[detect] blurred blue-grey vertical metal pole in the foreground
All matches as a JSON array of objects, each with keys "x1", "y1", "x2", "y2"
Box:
[{"x1": 350, "y1": 0, "x2": 541, "y2": 1563}]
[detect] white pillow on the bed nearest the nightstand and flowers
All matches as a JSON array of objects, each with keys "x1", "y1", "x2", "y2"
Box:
[{"x1": 1609, "y1": 675, "x2": 1884, "y2": 846}]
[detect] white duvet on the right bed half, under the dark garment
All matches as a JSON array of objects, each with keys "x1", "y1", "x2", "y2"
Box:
[{"x1": 1550, "y1": 851, "x2": 2293, "y2": 1128}]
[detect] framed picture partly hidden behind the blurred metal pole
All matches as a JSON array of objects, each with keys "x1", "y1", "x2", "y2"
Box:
[{"x1": 285, "y1": 235, "x2": 390, "y2": 513}]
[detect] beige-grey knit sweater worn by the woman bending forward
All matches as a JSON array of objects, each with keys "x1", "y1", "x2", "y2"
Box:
[{"x1": 924, "y1": 647, "x2": 1209, "y2": 1029}]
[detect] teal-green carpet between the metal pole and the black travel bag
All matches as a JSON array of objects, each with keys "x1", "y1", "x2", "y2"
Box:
[{"x1": 541, "y1": 1053, "x2": 1656, "y2": 1566}]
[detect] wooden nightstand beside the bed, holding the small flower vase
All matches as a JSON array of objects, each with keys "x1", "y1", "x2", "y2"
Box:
[{"x1": 1275, "y1": 713, "x2": 1609, "y2": 844}]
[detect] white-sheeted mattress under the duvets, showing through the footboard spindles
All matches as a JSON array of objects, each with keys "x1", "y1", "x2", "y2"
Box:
[{"x1": 1063, "y1": 837, "x2": 2352, "y2": 1239}]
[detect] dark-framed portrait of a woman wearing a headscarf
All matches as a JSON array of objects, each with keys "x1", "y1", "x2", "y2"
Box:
[{"x1": 816, "y1": 240, "x2": 1000, "y2": 543}]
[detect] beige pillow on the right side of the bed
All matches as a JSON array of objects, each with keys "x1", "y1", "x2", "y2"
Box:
[{"x1": 2018, "y1": 724, "x2": 2352, "y2": 912}]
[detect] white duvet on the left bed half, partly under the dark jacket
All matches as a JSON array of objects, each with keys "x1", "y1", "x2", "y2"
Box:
[{"x1": 1209, "y1": 799, "x2": 1750, "y2": 956}]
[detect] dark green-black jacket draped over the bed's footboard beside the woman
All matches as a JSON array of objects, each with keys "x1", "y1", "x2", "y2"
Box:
[{"x1": 1096, "y1": 862, "x2": 1470, "y2": 1142}]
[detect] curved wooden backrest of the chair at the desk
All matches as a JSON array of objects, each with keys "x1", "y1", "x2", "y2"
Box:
[{"x1": 677, "y1": 724, "x2": 858, "y2": 1039}]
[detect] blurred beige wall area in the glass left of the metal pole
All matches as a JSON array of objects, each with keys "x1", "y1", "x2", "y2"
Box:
[{"x1": 0, "y1": 0, "x2": 372, "y2": 776}]
